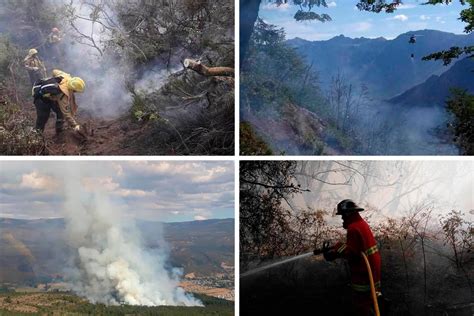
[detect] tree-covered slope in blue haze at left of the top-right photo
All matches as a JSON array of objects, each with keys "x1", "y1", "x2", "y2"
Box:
[{"x1": 240, "y1": 19, "x2": 350, "y2": 155}]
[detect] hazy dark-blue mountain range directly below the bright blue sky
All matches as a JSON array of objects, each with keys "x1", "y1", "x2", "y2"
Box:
[{"x1": 287, "y1": 30, "x2": 474, "y2": 99}]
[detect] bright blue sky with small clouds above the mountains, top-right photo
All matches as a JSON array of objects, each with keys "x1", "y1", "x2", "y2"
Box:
[{"x1": 259, "y1": 0, "x2": 466, "y2": 40}]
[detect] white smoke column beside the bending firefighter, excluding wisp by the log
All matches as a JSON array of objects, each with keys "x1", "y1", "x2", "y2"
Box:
[{"x1": 59, "y1": 1, "x2": 132, "y2": 118}]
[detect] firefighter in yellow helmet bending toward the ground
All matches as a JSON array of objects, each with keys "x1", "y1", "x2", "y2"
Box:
[{"x1": 33, "y1": 69, "x2": 86, "y2": 134}]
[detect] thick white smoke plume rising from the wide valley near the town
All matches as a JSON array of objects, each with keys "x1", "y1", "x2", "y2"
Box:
[{"x1": 64, "y1": 171, "x2": 202, "y2": 306}]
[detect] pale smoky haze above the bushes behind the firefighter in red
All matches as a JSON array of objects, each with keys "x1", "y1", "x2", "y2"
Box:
[{"x1": 290, "y1": 161, "x2": 474, "y2": 223}]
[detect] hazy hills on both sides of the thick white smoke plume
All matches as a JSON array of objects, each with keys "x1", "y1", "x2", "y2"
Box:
[{"x1": 0, "y1": 218, "x2": 234, "y2": 284}]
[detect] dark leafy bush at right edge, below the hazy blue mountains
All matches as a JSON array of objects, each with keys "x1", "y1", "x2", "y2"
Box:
[{"x1": 446, "y1": 89, "x2": 474, "y2": 155}]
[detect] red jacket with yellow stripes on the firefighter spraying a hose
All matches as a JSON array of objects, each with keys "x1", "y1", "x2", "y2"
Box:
[{"x1": 331, "y1": 213, "x2": 381, "y2": 292}]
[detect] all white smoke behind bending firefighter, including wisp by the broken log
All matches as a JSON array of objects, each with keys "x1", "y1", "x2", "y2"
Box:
[{"x1": 48, "y1": 0, "x2": 187, "y2": 119}]
